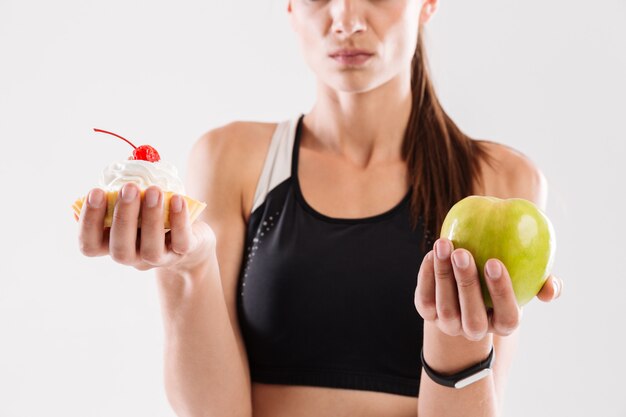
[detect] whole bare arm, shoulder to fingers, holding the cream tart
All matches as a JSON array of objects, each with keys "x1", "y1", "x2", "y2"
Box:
[{"x1": 78, "y1": 123, "x2": 275, "y2": 417}]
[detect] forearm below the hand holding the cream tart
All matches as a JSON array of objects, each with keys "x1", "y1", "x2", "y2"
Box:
[{"x1": 157, "y1": 250, "x2": 251, "y2": 417}]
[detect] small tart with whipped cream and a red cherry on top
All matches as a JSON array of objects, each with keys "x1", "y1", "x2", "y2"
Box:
[{"x1": 72, "y1": 129, "x2": 206, "y2": 229}]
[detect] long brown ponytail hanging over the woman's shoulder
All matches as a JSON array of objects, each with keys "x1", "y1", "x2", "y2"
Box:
[{"x1": 402, "y1": 28, "x2": 487, "y2": 242}]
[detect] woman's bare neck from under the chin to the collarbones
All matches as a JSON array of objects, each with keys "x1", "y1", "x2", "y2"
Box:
[{"x1": 305, "y1": 70, "x2": 412, "y2": 167}]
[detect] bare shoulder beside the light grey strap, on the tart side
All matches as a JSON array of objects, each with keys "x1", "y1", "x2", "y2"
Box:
[{"x1": 187, "y1": 121, "x2": 277, "y2": 218}]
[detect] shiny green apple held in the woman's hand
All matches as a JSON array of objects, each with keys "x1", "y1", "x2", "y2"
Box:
[{"x1": 441, "y1": 196, "x2": 556, "y2": 307}]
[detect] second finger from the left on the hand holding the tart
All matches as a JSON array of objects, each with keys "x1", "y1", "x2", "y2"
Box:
[{"x1": 109, "y1": 183, "x2": 141, "y2": 265}]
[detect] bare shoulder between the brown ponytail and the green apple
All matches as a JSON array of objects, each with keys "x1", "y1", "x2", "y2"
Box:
[{"x1": 476, "y1": 141, "x2": 548, "y2": 208}]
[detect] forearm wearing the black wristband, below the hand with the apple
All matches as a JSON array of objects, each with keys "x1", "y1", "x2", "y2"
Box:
[{"x1": 418, "y1": 322, "x2": 498, "y2": 417}]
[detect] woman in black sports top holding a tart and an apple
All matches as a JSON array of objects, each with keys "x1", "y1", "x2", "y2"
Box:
[{"x1": 80, "y1": 0, "x2": 560, "y2": 417}]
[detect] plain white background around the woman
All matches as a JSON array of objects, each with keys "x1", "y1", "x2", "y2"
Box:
[{"x1": 0, "y1": 0, "x2": 626, "y2": 417}]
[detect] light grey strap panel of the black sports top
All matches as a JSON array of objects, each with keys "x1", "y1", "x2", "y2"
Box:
[{"x1": 251, "y1": 116, "x2": 299, "y2": 213}]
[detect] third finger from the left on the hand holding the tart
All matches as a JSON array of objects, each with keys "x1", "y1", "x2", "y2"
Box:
[{"x1": 139, "y1": 186, "x2": 165, "y2": 266}]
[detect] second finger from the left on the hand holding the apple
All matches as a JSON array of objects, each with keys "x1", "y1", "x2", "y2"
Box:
[{"x1": 435, "y1": 239, "x2": 462, "y2": 336}]
